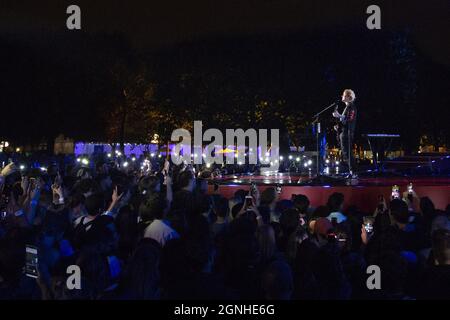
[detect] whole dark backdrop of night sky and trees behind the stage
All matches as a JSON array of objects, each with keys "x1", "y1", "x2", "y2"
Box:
[{"x1": 0, "y1": 0, "x2": 450, "y2": 151}]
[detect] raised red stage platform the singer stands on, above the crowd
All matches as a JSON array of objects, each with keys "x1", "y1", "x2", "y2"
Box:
[{"x1": 209, "y1": 173, "x2": 450, "y2": 212}]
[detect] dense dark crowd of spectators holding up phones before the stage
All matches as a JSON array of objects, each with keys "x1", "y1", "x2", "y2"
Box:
[{"x1": 0, "y1": 155, "x2": 450, "y2": 300}]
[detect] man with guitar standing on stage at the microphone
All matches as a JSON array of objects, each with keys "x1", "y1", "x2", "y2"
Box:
[{"x1": 333, "y1": 89, "x2": 357, "y2": 174}]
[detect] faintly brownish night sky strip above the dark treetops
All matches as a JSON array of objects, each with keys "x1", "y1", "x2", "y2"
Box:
[{"x1": 0, "y1": 0, "x2": 450, "y2": 66}]
